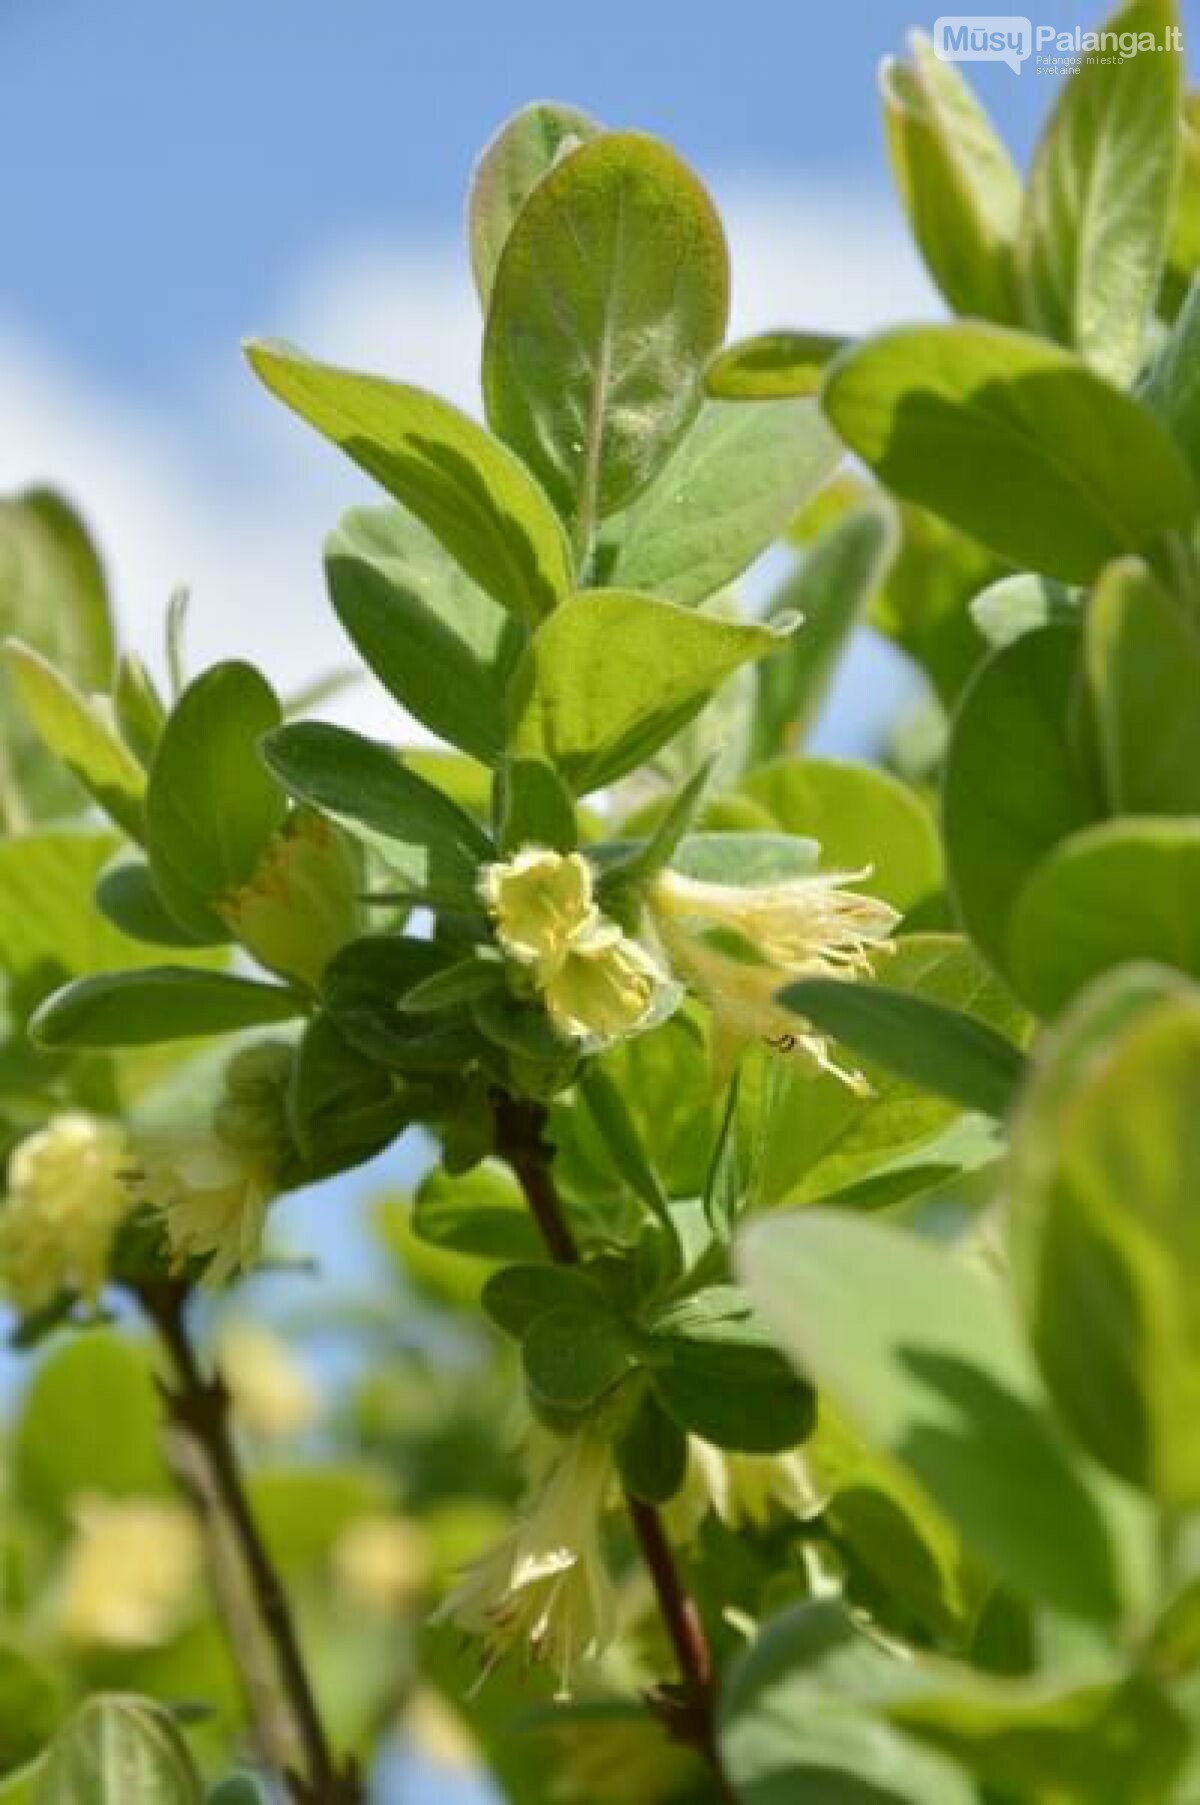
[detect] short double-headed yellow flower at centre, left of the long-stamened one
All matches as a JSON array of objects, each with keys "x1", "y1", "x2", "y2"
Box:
[{"x1": 482, "y1": 847, "x2": 666, "y2": 1045}]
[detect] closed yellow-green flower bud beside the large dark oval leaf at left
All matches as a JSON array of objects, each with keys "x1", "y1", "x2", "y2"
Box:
[{"x1": 218, "y1": 809, "x2": 363, "y2": 989}]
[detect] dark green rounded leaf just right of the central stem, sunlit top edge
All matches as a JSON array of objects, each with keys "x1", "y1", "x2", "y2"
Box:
[{"x1": 639, "y1": 1285, "x2": 816, "y2": 1453}]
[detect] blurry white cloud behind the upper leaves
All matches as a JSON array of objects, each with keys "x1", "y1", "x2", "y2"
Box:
[{"x1": 0, "y1": 184, "x2": 933, "y2": 733}]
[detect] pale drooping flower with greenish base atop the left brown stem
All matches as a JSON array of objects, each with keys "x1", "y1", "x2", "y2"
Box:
[{"x1": 137, "y1": 1041, "x2": 291, "y2": 1285}]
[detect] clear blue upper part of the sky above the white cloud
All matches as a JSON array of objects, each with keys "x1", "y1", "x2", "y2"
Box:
[{"x1": 0, "y1": 0, "x2": 1061, "y2": 388}]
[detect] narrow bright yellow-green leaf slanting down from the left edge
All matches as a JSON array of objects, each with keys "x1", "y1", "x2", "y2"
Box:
[{"x1": 4, "y1": 639, "x2": 146, "y2": 839}]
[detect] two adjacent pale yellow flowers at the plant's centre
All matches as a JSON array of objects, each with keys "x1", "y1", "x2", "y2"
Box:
[{"x1": 482, "y1": 847, "x2": 897, "y2": 1087}]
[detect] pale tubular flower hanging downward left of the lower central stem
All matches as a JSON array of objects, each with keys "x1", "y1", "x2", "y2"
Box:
[{"x1": 435, "y1": 1431, "x2": 615, "y2": 1699}]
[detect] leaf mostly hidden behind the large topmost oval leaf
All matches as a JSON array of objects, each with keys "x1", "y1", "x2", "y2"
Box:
[{"x1": 467, "y1": 101, "x2": 601, "y2": 310}]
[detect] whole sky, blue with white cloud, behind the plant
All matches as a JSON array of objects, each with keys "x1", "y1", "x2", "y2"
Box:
[{"x1": 0, "y1": 0, "x2": 1082, "y2": 749}]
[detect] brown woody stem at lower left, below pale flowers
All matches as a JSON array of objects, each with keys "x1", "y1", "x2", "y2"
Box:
[{"x1": 139, "y1": 1282, "x2": 363, "y2": 1805}]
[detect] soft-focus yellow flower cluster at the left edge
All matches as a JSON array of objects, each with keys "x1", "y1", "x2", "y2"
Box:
[{"x1": 0, "y1": 1112, "x2": 134, "y2": 1312}]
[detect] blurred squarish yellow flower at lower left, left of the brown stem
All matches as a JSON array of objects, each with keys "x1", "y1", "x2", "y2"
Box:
[{"x1": 60, "y1": 1498, "x2": 202, "y2": 1648}]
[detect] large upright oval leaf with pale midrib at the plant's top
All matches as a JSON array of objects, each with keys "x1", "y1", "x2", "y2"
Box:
[{"x1": 484, "y1": 132, "x2": 729, "y2": 540}]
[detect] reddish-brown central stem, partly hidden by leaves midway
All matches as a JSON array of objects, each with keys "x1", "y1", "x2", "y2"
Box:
[{"x1": 493, "y1": 1092, "x2": 733, "y2": 1801}]
